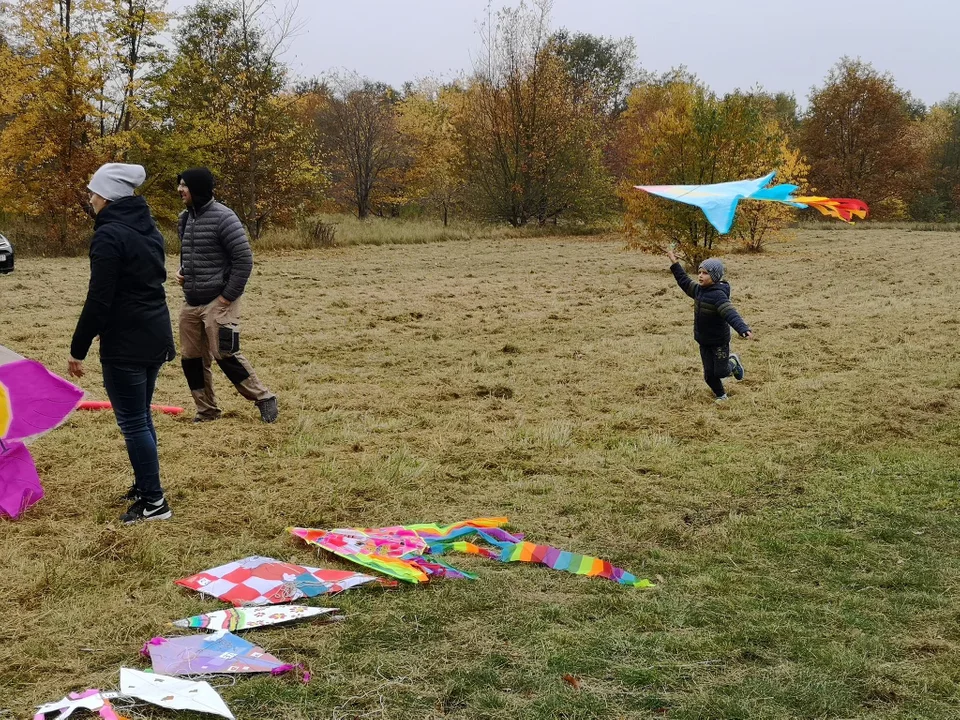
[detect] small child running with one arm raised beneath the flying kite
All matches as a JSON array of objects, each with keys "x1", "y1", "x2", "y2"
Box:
[{"x1": 667, "y1": 250, "x2": 753, "y2": 402}]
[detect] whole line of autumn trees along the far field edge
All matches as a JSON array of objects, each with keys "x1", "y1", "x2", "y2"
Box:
[{"x1": 0, "y1": 0, "x2": 960, "y2": 250}]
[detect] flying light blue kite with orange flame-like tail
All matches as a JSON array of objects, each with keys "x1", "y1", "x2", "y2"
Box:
[{"x1": 635, "y1": 173, "x2": 869, "y2": 235}]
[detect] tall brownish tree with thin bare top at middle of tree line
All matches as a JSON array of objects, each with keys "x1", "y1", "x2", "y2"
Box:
[{"x1": 457, "y1": 0, "x2": 612, "y2": 226}]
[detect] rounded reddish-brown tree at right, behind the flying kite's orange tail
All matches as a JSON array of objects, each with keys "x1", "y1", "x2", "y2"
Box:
[{"x1": 801, "y1": 57, "x2": 922, "y2": 218}]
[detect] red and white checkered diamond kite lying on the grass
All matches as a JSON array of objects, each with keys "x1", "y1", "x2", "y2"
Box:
[{"x1": 174, "y1": 555, "x2": 396, "y2": 606}]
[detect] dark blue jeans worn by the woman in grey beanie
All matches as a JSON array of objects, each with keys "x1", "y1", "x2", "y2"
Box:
[{"x1": 103, "y1": 363, "x2": 163, "y2": 501}]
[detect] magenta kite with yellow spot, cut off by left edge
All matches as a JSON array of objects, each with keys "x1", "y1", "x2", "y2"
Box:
[{"x1": 0, "y1": 347, "x2": 83, "y2": 518}]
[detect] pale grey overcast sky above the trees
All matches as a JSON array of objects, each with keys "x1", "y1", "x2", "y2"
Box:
[{"x1": 168, "y1": 0, "x2": 960, "y2": 105}]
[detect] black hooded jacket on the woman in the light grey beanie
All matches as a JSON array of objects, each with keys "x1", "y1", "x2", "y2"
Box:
[{"x1": 70, "y1": 197, "x2": 176, "y2": 365}]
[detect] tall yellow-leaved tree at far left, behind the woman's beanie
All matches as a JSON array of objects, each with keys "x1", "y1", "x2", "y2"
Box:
[{"x1": 0, "y1": 0, "x2": 104, "y2": 249}]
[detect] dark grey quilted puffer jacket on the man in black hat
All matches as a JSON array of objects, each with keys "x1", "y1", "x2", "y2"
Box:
[{"x1": 179, "y1": 200, "x2": 253, "y2": 305}]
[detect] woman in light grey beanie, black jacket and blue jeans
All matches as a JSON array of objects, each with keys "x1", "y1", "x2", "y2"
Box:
[{"x1": 68, "y1": 163, "x2": 176, "y2": 524}]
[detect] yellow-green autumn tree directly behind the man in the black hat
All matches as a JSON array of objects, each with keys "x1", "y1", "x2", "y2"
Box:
[{"x1": 155, "y1": 0, "x2": 322, "y2": 238}]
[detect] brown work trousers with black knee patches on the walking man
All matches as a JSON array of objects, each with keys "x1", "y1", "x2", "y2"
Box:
[{"x1": 180, "y1": 299, "x2": 274, "y2": 420}]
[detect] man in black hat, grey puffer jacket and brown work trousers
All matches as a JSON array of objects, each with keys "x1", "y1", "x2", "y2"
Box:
[{"x1": 177, "y1": 168, "x2": 278, "y2": 422}]
